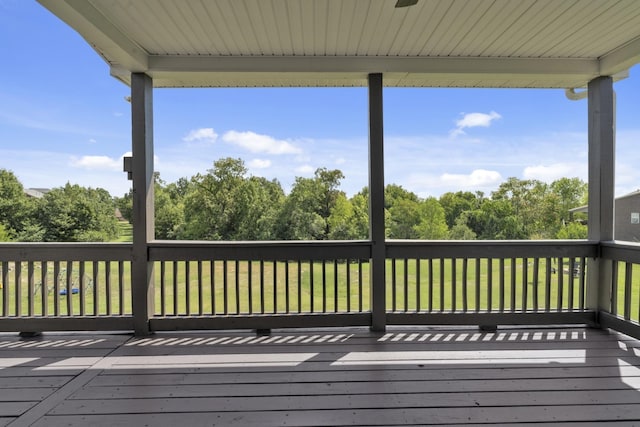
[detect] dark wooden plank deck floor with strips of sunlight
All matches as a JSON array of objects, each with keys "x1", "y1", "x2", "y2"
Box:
[{"x1": 0, "y1": 328, "x2": 640, "y2": 427}]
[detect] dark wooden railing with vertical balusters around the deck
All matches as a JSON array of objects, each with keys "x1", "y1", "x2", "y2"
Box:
[{"x1": 5, "y1": 241, "x2": 640, "y2": 330}]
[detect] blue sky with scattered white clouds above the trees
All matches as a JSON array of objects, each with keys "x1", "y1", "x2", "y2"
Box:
[{"x1": 0, "y1": 0, "x2": 640, "y2": 197}]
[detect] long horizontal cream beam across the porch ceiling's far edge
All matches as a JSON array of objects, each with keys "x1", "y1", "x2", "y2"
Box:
[{"x1": 145, "y1": 55, "x2": 599, "y2": 88}]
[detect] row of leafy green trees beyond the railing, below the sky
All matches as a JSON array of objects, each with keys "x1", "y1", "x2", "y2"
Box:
[{"x1": 0, "y1": 158, "x2": 587, "y2": 241}]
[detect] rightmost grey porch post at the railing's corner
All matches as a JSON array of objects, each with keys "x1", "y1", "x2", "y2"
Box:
[{"x1": 587, "y1": 77, "x2": 615, "y2": 311}]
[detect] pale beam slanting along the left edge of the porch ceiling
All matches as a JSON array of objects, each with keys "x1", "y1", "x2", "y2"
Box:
[{"x1": 38, "y1": 0, "x2": 148, "y2": 72}]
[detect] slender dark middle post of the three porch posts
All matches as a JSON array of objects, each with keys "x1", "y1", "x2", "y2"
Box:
[{"x1": 368, "y1": 74, "x2": 386, "y2": 332}]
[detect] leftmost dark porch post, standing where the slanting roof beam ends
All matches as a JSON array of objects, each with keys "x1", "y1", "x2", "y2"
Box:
[{"x1": 131, "y1": 73, "x2": 155, "y2": 335}]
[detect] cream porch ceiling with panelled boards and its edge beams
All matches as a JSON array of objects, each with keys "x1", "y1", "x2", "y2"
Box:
[{"x1": 38, "y1": 0, "x2": 640, "y2": 88}]
